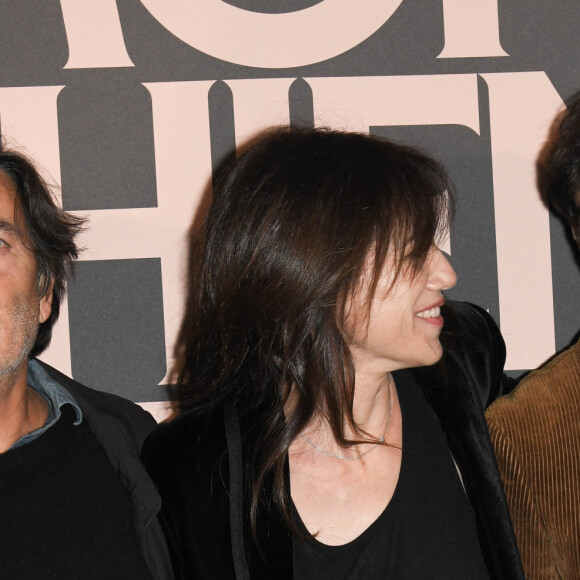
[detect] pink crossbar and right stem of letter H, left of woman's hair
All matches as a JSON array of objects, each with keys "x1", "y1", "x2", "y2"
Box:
[{"x1": 73, "y1": 81, "x2": 213, "y2": 390}]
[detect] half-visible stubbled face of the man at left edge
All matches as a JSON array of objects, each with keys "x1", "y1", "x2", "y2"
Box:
[{"x1": 0, "y1": 171, "x2": 52, "y2": 390}]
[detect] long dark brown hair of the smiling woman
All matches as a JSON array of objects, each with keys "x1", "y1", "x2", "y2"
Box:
[{"x1": 179, "y1": 128, "x2": 453, "y2": 539}]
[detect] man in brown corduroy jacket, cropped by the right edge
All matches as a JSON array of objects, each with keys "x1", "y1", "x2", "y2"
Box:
[{"x1": 487, "y1": 93, "x2": 580, "y2": 580}]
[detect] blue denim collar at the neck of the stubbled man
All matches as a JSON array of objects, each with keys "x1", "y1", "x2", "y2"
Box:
[{"x1": 10, "y1": 359, "x2": 83, "y2": 449}]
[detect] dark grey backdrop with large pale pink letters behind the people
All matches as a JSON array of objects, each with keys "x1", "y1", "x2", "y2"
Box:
[{"x1": 0, "y1": 0, "x2": 580, "y2": 416}]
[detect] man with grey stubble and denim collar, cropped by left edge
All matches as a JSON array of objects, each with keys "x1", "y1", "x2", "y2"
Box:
[{"x1": 0, "y1": 149, "x2": 171, "y2": 580}]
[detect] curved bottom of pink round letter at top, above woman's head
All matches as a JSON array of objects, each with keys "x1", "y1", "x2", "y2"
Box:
[{"x1": 141, "y1": 0, "x2": 403, "y2": 68}]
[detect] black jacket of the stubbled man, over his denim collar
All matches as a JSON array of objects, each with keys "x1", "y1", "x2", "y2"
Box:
[{"x1": 38, "y1": 361, "x2": 173, "y2": 580}]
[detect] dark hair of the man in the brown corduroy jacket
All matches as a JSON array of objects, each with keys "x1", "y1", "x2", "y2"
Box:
[{"x1": 538, "y1": 92, "x2": 580, "y2": 222}]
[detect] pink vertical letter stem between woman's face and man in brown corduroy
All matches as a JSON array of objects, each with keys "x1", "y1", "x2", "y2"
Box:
[{"x1": 481, "y1": 72, "x2": 563, "y2": 369}]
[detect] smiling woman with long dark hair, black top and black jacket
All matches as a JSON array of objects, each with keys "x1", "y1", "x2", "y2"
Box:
[{"x1": 144, "y1": 129, "x2": 523, "y2": 580}]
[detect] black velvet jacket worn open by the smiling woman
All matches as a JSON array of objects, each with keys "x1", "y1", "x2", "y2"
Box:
[{"x1": 143, "y1": 303, "x2": 524, "y2": 580}]
